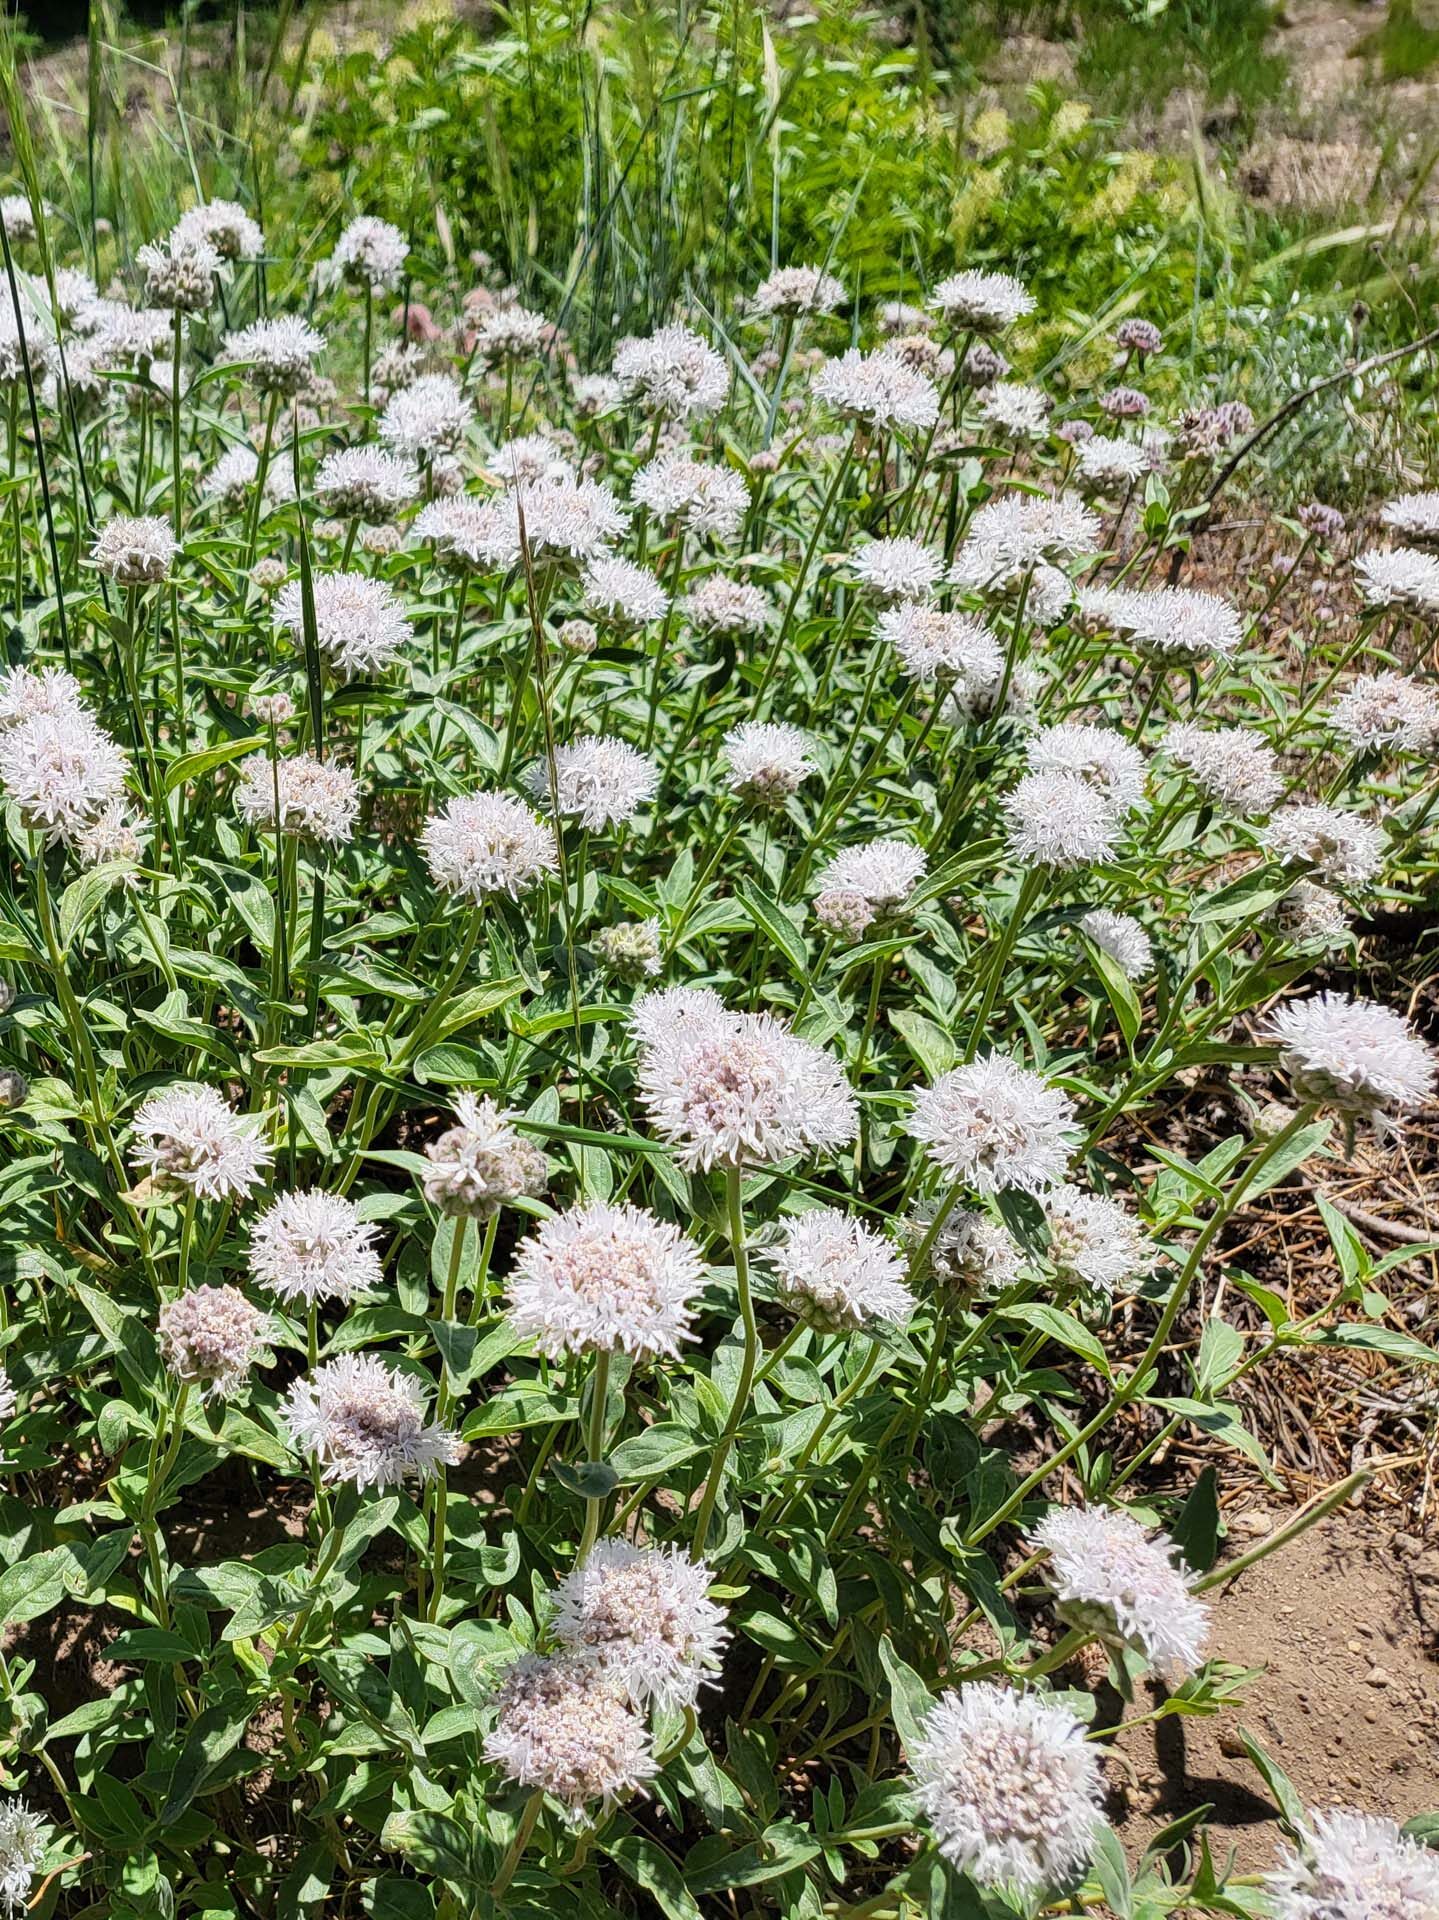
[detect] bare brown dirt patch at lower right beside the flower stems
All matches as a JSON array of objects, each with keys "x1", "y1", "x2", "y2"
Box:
[{"x1": 1120, "y1": 1511, "x2": 1439, "y2": 1872}]
